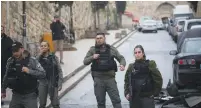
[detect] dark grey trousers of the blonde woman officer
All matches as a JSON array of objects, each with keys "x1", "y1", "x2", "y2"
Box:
[{"x1": 39, "y1": 84, "x2": 60, "y2": 108}]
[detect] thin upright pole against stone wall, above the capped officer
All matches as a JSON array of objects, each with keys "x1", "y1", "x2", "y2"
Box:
[{"x1": 22, "y1": 1, "x2": 27, "y2": 49}]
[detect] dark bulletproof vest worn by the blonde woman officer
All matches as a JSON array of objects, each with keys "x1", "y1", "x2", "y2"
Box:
[{"x1": 39, "y1": 55, "x2": 59, "y2": 86}]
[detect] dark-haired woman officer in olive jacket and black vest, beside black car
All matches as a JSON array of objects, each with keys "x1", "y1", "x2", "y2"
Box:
[{"x1": 124, "y1": 45, "x2": 163, "y2": 108}]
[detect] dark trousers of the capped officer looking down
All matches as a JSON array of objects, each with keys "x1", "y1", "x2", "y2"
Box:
[{"x1": 9, "y1": 92, "x2": 38, "y2": 108}]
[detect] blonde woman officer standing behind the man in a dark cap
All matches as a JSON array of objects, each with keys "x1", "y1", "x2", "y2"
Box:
[{"x1": 38, "y1": 41, "x2": 63, "y2": 108}]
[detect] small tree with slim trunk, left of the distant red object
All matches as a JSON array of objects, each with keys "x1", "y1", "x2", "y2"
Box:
[{"x1": 115, "y1": 1, "x2": 126, "y2": 27}]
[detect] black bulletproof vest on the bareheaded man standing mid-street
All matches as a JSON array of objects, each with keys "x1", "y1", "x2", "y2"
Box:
[{"x1": 91, "y1": 44, "x2": 117, "y2": 72}]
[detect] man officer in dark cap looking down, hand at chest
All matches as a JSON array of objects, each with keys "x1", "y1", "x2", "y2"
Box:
[{"x1": 1, "y1": 42, "x2": 45, "y2": 108}]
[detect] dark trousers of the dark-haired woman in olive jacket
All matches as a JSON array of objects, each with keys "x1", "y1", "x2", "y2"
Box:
[{"x1": 132, "y1": 97, "x2": 155, "y2": 108}]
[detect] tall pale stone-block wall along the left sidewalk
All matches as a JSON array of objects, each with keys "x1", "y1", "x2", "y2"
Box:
[{"x1": 1, "y1": 1, "x2": 114, "y2": 41}]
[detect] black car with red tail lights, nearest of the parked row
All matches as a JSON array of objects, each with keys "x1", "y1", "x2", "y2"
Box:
[{"x1": 170, "y1": 37, "x2": 201, "y2": 89}]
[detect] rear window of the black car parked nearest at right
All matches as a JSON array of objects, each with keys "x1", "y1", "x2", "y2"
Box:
[{"x1": 182, "y1": 39, "x2": 201, "y2": 53}]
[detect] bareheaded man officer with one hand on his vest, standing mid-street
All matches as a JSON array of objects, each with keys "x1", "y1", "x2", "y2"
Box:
[{"x1": 84, "y1": 33, "x2": 126, "y2": 108}]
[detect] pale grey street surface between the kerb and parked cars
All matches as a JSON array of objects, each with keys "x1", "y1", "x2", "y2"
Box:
[{"x1": 60, "y1": 30, "x2": 176, "y2": 108}]
